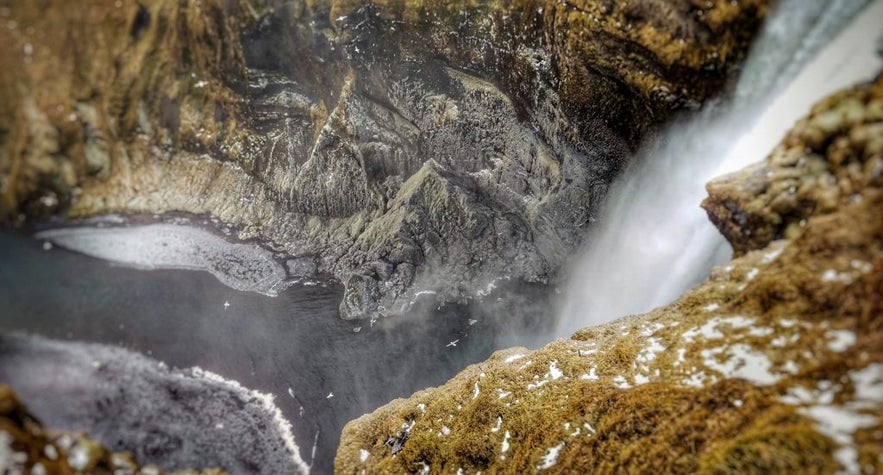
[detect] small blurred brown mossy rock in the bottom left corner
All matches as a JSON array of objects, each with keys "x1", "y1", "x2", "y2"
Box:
[{"x1": 0, "y1": 384, "x2": 226, "y2": 475}]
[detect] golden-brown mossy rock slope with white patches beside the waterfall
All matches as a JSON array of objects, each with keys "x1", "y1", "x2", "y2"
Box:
[{"x1": 336, "y1": 78, "x2": 883, "y2": 473}]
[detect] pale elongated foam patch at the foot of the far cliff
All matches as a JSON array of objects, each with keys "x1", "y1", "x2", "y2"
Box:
[{"x1": 36, "y1": 223, "x2": 288, "y2": 296}]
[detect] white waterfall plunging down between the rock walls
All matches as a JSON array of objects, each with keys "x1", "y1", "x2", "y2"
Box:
[{"x1": 557, "y1": 0, "x2": 883, "y2": 337}]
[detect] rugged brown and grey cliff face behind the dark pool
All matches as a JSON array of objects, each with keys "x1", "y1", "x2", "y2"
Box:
[{"x1": 0, "y1": 0, "x2": 768, "y2": 318}]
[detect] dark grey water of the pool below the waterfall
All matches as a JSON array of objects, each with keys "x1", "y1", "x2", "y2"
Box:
[{"x1": 0, "y1": 230, "x2": 552, "y2": 473}]
